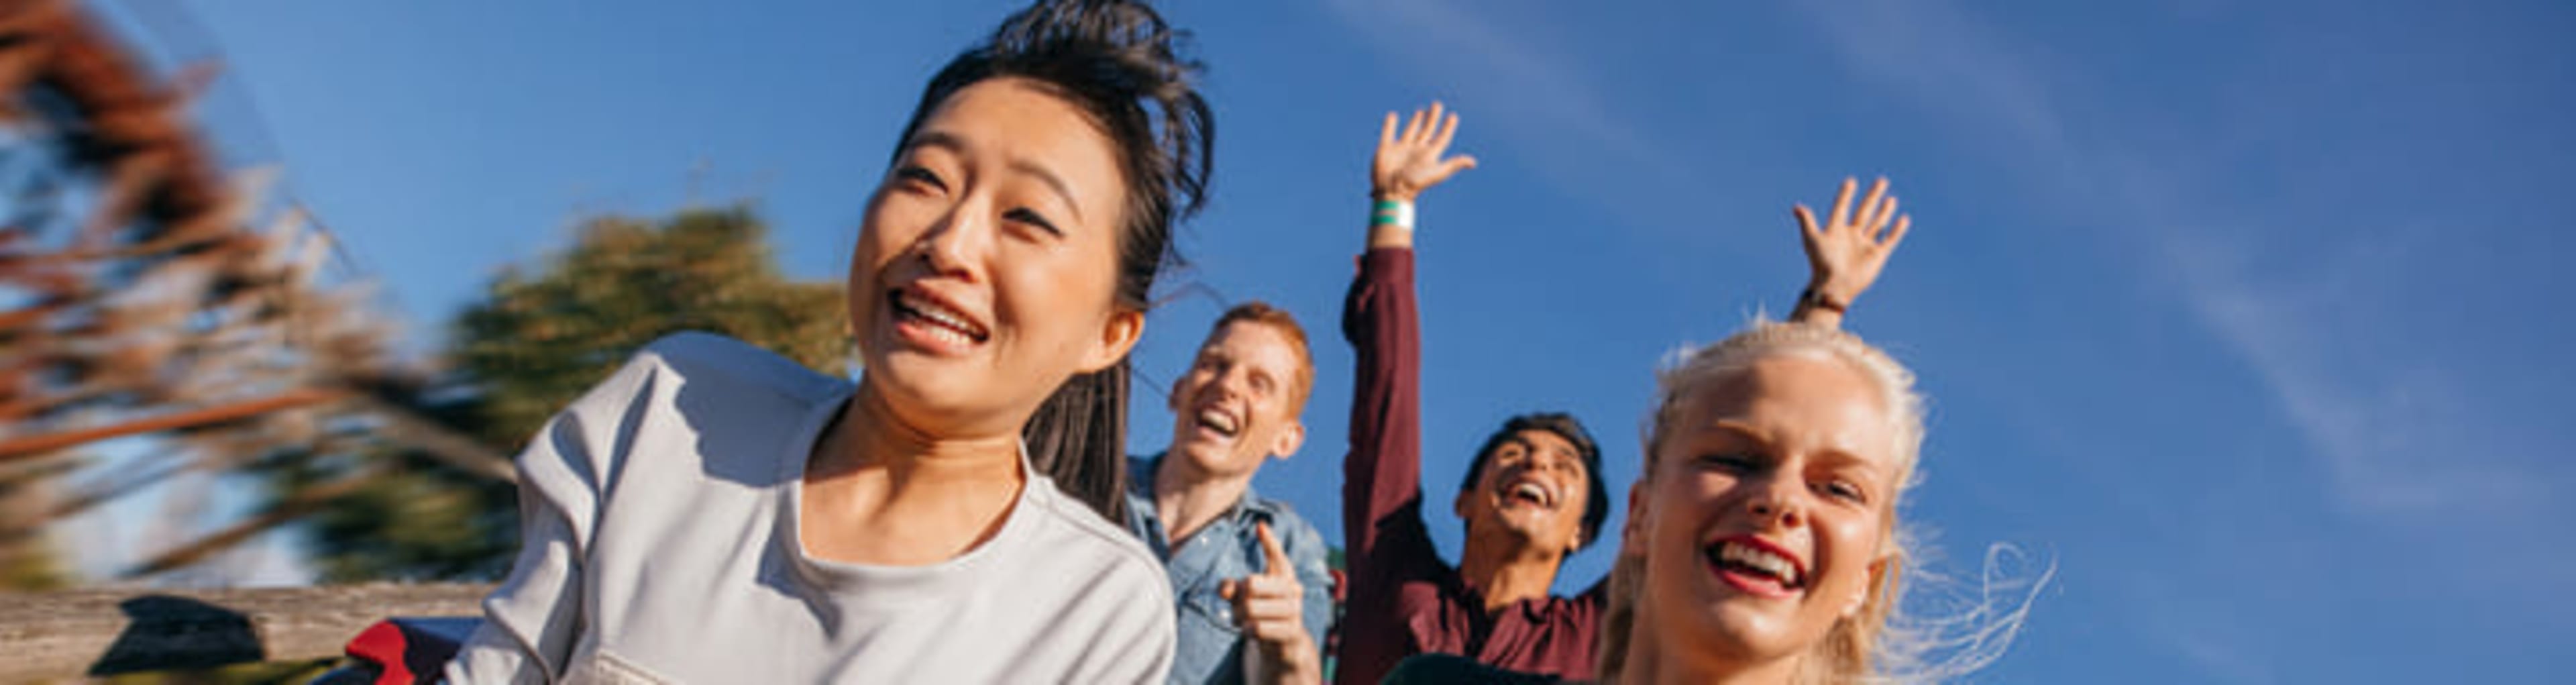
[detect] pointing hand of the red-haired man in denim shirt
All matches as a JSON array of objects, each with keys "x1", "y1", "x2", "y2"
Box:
[{"x1": 1216, "y1": 523, "x2": 1324, "y2": 682}]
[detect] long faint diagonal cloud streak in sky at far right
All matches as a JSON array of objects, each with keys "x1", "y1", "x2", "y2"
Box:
[{"x1": 1801, "y1": 0, "x2": 2566, "y2": 520}]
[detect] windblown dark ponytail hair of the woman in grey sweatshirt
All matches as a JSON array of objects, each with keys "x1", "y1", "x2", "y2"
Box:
[{"x1": 894, "y1": 0, "x2": 1216, "y2": 523}]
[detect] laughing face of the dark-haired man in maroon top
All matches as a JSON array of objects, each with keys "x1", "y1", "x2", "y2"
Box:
[{"x1": 1456, "y1": 427, "x2": 1592, "y2": 554}]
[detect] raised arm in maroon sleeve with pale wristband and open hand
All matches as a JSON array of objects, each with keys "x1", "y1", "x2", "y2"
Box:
[{"x1": 1334, "y1": 103, "x2": 1476, "y2": 682}]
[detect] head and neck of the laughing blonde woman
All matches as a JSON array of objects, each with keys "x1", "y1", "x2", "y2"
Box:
[{"x1": 1602, "y1": 325, "x2": 1922, "y2": 682}]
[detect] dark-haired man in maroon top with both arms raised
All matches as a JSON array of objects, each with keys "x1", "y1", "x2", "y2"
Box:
[{"x1": 1334, "y1": 103, "x2": 1907, "y2": 682}]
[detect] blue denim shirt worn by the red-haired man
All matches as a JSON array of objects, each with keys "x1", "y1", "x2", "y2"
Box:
[{"x1": 1126, "y1": 454, "x2": 1332, "y2": 682}]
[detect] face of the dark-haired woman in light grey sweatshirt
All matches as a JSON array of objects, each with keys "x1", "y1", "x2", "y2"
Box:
[{"x1": 850, "y1": 77, "x2": 1144, "y2": 435}]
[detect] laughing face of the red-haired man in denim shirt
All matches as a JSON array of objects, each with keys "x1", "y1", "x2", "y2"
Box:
[{"x1": 1169, "y1": 322, "x2": 1306, "y2": 476}]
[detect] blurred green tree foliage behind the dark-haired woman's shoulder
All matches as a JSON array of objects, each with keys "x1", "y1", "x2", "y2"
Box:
[{"x1": 278, "y1": 206, "x2": 850, "y2": 582}]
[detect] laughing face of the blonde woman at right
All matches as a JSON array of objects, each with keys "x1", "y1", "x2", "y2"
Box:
[{"x1": 1623, "y1": 356, "x2": 1898, "y2": 667}]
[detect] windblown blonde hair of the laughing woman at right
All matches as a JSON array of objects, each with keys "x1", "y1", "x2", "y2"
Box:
[{"x1": 1600, "y1": 319, "x2": 2045, "y2": 682}]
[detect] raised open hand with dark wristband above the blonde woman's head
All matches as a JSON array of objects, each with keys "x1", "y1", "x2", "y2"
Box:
[{"x1": 1788, "y1": 178, "x2": 1914, "y2": 327}]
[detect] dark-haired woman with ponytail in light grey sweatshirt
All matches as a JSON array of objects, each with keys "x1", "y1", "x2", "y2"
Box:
[{"x1": 445, "y1": 0, "x2": 1214, "y2": 682}]
